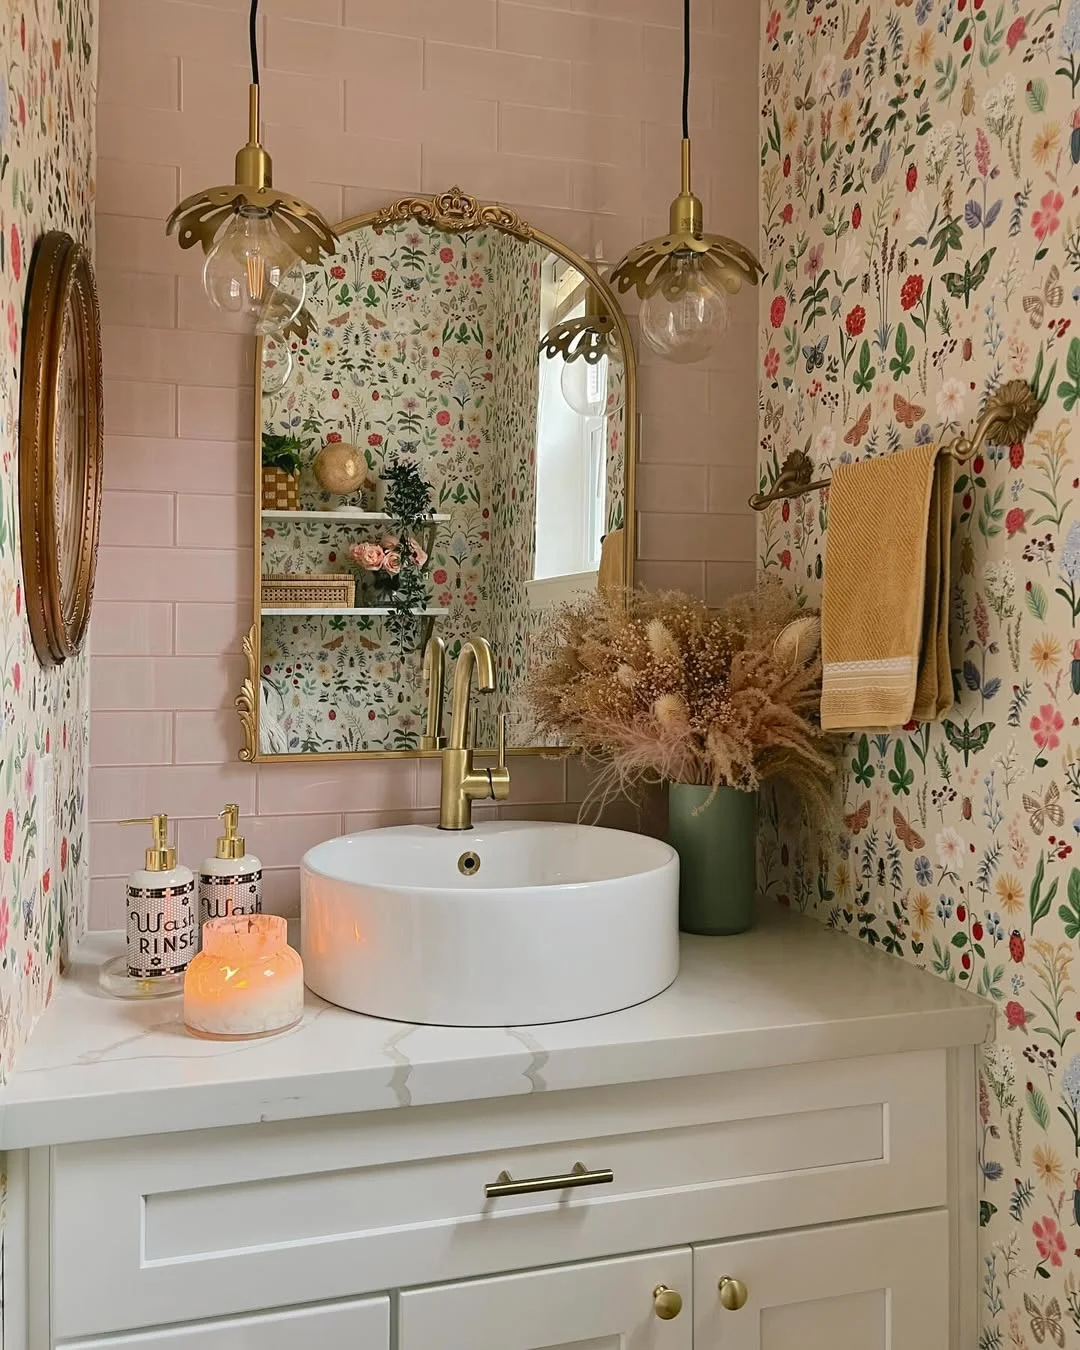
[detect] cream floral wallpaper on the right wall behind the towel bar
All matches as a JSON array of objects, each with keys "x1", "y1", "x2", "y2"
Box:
[{"x1": 759, "y1": 0, "x2": 1080, "y2": 1333}]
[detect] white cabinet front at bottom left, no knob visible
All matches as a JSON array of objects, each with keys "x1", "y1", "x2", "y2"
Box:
[{"x1": 57, "y1": 1297, "x2": 390, "y2": 1350}]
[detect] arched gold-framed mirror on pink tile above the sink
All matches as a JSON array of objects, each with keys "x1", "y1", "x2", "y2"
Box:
[{"x1": 238, "y1": 188, "x2": 637, "y2": 760}]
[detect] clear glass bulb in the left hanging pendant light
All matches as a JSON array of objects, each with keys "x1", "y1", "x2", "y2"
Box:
[{"x1": 203, "y1": 207, "x2": 305, "y2": 333}]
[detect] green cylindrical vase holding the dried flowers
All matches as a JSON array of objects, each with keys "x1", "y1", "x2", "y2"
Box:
[{"x1": 667, "y1": 783, "x2": 757, "y2": 937}]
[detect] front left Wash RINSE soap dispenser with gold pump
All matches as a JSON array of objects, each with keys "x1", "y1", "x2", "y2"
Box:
[{"x1": 99, "y1": 811, "x2": 198, "y2": 999}]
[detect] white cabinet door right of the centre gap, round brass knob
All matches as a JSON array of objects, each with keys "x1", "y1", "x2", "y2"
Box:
[{"x1": 694, "y1": 1211, "x2": 949, "y2": 1350}]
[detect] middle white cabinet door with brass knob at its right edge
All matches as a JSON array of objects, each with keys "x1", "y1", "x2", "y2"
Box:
[{"x1": 398, "y1": 1247, "x2": 693, "y2": 1350}]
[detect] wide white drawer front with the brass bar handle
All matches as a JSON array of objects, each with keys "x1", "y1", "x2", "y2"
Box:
[{"x1": 53, "y1": 1052, "x2": 945, "y2": 1337}]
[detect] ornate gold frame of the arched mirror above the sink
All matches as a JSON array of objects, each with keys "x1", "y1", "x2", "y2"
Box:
[{"x1": 236, "y1": 186, "x2": 639, "y2": 764}]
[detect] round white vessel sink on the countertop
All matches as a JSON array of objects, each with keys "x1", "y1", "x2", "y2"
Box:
[{"x1": 301, "y1": 822, "x2": 679, "y2": 1026}]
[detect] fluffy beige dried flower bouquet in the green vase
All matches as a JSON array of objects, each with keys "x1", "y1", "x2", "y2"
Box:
[{"x1": 529, "y1": 585, "x2": 833, "y2": 802}]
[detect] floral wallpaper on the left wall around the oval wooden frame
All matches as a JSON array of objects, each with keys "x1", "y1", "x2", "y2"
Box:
[{"x1": 0, "y1": 0, "x2": 97, "y2": 1081}]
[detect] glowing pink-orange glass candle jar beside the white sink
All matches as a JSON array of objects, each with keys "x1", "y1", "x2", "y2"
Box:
[{"x1": 184, "y1": 914, "x2": 304, "y2": 1041}]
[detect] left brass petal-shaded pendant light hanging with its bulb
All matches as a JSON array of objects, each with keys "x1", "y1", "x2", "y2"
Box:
[{"x1": 166, "y1": 0, "x2": 338, "y2": 333}]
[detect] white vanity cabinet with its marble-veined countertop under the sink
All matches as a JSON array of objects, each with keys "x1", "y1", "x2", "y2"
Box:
[{"x1": 0, "y1": 917, "x2": 992, "y2": 1350}]
